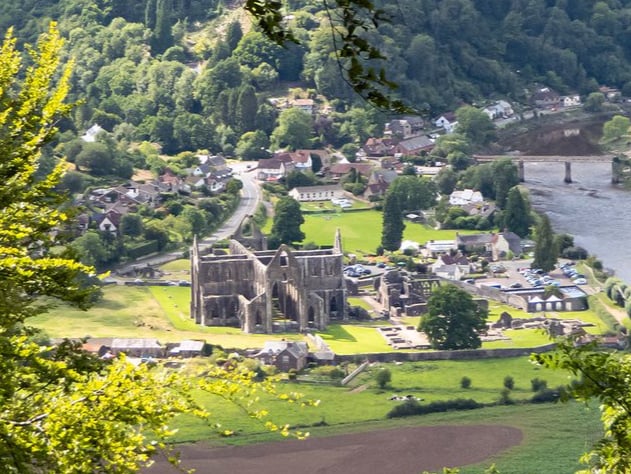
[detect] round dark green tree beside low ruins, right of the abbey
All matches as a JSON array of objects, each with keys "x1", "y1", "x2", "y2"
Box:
[{"x1": 419, "y1": 285, "x2": 488, "y2": 349}]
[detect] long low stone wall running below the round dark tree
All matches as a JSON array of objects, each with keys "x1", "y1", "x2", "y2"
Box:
[{"x1": 335, "y1": 344, "x2": 556, "y2": 363}]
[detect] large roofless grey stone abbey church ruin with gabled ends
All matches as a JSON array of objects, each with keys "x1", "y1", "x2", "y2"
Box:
[{"x1": 191, "y1": 230, "x2": 346, "y2": 333}]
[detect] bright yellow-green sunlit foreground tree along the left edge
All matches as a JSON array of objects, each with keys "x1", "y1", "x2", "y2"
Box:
[{"x1": 0, "y1": 24, "x2": 308, "y2": 474}]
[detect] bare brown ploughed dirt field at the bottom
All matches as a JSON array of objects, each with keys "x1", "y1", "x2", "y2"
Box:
[{"x1": 143, "y1": 425, "x2": 522, "y2": 474}]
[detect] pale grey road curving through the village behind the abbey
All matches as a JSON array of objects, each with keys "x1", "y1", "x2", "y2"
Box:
[{"x1": 116, "y1": 161, "x2": 261, "y2": 275}]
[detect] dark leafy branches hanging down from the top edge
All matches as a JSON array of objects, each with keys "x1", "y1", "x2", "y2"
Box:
[{"x1": 244, "y1": 0, "x2": 412, "y2": 113}]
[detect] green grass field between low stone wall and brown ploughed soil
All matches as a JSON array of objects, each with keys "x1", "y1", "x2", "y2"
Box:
[{"x1": 176, "y1": 358, "x2": 601, "y2": 474}]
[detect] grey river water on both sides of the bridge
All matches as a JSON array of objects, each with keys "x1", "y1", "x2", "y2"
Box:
[{"x1": 512, "y1": 119, "x2": 631, "y2": 282}]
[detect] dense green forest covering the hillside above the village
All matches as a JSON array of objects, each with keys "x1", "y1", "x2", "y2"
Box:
[{"x1": 6, "y1": 0, "x2": 631, "y2": 159}]
